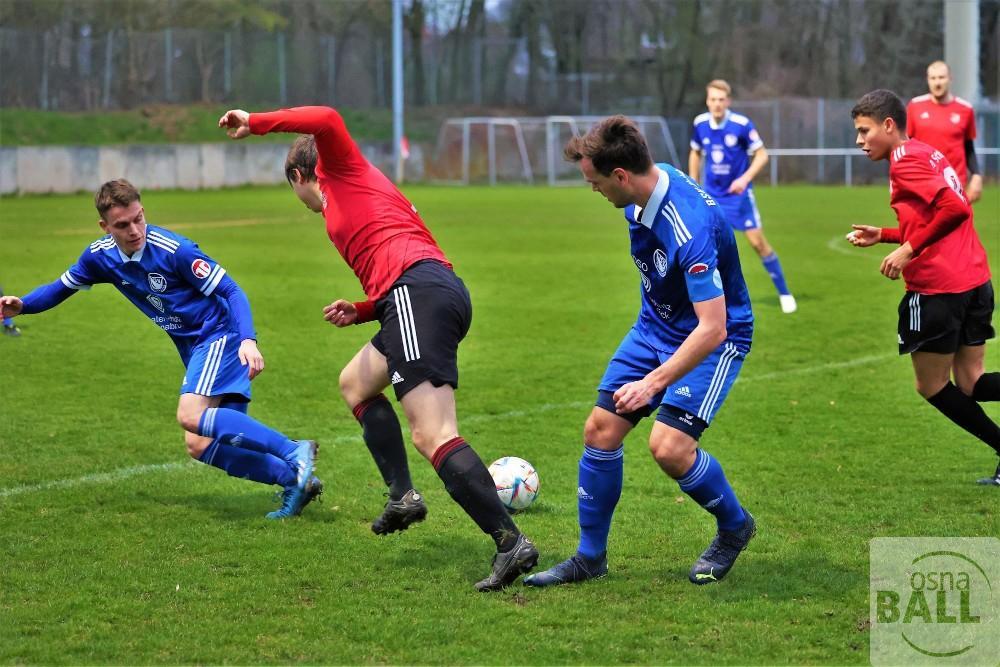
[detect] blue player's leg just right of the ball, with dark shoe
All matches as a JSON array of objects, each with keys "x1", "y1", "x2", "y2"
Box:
[{"x1": 524, "y1": 402, "x2": 632, "y2": 586}]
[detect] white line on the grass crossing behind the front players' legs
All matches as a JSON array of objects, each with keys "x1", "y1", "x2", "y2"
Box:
[{"x1": 0, "y1": 339, "x2": 997, "y2": 498}]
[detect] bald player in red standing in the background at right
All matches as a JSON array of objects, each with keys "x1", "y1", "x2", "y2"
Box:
[{"x1": 906, "y1": 60, "x2": 983, "y2": 202}]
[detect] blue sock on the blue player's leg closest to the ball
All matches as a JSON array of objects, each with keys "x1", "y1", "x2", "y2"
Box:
[{"x1": 576, "y1": 445, "x2": 625, "y2": 559}]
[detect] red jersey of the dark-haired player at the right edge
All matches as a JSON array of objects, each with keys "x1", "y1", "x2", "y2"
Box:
[{"x1": 883, "y1": 139, "x2": 990, "y2": 294}]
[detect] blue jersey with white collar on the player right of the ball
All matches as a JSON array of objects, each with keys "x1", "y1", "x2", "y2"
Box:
[{"x1": 625, "y1": 164, "x2": 753, "y2": 353}]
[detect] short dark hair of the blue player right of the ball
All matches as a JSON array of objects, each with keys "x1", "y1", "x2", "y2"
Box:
[{"x1": 563, "y1": 116, "x2": 653, "y2": 176}]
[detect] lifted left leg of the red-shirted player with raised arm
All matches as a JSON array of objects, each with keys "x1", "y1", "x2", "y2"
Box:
[{"x1": 340, "y1": 340, "x2": 412, "y2": 516}]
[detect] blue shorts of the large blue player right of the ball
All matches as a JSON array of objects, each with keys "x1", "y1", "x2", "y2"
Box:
[{"x1": 598, "y1": 328, "x2": 747, "y2": 424}]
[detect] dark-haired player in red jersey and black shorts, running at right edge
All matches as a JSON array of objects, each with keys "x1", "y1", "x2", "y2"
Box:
[{"x1": 847, "y1": 90, "x2": 1000, "y2": 486}]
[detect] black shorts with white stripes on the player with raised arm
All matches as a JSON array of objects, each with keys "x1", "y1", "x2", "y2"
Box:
[{"x1": 372, "y1": 260, "x2": 472, "y2": 400}]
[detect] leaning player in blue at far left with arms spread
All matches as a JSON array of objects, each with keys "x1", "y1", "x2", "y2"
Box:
[{"x1": 0, "y1": 180, "x2": 322, "y2": 519}]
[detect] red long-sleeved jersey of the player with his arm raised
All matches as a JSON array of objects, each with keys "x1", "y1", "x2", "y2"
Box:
[{"x1": 250, "y1": 107, "x2": 451, "y2": 301}]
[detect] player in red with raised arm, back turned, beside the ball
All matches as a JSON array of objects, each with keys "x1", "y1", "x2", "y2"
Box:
[{"x1": 219, "y1": 107, "x2": 538, "y2": 591}]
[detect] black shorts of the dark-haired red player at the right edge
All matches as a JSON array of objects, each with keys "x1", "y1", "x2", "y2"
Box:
[{"x1": 897, "y1": 280, "x2": 995, "y2": 354}]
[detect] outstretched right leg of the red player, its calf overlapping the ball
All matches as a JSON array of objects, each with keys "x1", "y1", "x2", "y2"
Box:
[{"x1": 400, "y1": 381, "x2": 538, "y2": 591}]
